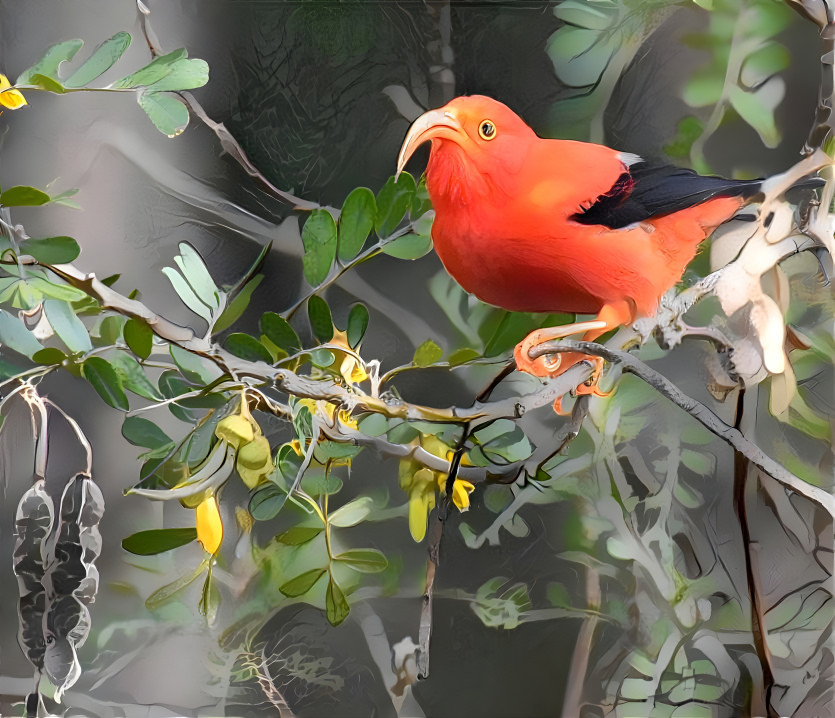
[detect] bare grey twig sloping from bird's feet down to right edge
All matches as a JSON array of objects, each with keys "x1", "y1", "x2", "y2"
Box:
[{"x1": 530, "y1": 339, "x2": 835, "y2": 518}]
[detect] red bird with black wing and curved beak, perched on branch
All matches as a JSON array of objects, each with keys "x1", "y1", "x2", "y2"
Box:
[{"x1": 397, "y1": 95, "x2": 761, "y2": 394}]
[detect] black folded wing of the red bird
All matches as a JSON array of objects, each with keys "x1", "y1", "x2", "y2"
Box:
[{"x1": 571, "y1": 161, "x2": 762, "y2": 229}]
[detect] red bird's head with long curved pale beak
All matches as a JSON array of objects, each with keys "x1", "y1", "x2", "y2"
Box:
[{"x1": 397, "y1": 95, "x2": 536, "y2": 201}]
